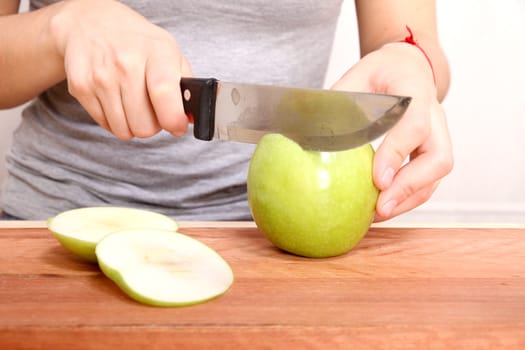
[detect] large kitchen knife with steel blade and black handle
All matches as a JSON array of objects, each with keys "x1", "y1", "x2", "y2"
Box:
[{"x1": 181, "y1": 78, "x2": 411, "y2": 151}]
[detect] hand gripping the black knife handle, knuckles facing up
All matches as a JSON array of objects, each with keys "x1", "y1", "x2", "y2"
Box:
[{"x1": 50, "y1": 0, "x2": 192, "y2": 140}]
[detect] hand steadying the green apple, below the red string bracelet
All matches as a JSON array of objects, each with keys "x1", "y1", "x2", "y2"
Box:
[{"x1": 333, "y1": 43, "x2": 453, "y2": 221}]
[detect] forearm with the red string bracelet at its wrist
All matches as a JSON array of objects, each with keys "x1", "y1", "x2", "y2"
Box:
[{"x1": 356, "y1": 0, "x2": 450, "y2": 100}]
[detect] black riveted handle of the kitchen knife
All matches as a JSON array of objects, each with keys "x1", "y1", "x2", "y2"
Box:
[{"x1": 180, "y1": 78, "x2": 218, "y2": 141}]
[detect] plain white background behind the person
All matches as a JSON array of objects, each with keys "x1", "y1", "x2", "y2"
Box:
[{"x1": 0, "y1": 0, "x2": 525, "y2": 224}]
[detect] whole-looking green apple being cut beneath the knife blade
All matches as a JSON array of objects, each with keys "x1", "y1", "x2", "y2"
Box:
[{"x1": 247, "y1": 134, "x2": 379, "y2": 258}]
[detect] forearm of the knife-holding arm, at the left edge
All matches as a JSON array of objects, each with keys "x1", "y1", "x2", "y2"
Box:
[{"x1": 0, "y1": 3, "x2": 65, "y2": 108}]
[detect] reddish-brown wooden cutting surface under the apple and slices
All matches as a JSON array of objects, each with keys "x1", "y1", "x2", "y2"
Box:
[{"x1": 0, "y1": 224, "x2": 525, "y2": 349}]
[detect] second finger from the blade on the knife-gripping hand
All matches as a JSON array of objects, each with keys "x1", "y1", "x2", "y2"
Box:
[{"x1": 117, "y1": 56, "x2": 161, "y2": 138}]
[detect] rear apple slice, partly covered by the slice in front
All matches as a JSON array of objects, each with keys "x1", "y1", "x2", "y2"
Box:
[{"x1": 47, "y1": 207, "x2": 178, "y2": 262}]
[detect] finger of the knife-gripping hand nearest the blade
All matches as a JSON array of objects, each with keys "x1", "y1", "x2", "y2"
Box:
[{"x1": 146, "y1": 50, "x2": 188, "y2": 136}]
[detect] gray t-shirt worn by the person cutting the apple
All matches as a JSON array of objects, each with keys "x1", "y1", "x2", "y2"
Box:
[{"x1": 1, "y1": 0, "x2": 342, "y2": 220}]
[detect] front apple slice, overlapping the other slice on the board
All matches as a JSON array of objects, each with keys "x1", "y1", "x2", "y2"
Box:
[{"x1": 96, "y1": 229, "x2": 233, "y2": 306}]
